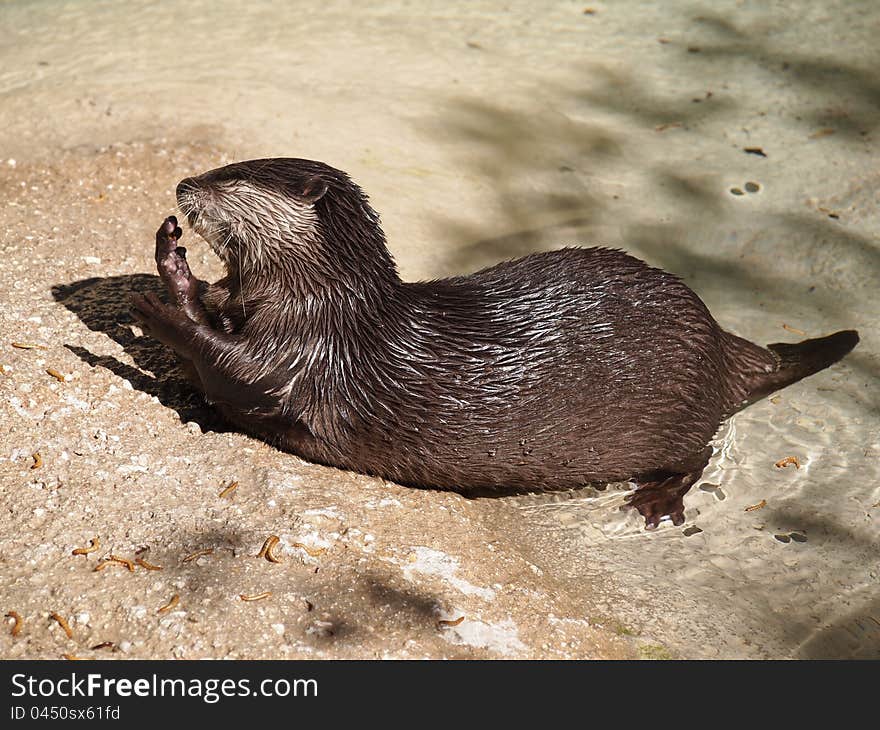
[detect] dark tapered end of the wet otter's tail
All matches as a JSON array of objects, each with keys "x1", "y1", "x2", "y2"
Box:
[{"x1": 748, "y1": 330, "x2": 859, "y2": 403}]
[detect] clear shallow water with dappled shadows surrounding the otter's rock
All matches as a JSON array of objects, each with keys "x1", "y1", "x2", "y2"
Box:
[{"x1": 0, "y1": 0, "x2": 880, "y2": 657}]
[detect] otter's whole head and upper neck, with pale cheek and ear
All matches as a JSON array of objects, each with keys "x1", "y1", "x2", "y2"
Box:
[{"x1": 177, "y1": 158, "x2": 399, "y2": 294}]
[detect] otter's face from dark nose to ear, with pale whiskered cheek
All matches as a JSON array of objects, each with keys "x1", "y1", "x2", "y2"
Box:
[{"x1": 177, "y1": 159, "x2": 330, "y2": 270}]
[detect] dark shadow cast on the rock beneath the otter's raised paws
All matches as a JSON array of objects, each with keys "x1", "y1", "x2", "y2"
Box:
[{"x1": 51, "y1": 274, "x2": 231, "y2": 432}]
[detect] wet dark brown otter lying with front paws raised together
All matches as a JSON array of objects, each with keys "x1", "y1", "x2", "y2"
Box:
[{"x1": 132, "y1": 159, "x2": 859, "y2": 528}]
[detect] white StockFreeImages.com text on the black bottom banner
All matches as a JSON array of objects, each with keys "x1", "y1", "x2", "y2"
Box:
[{"x1": 12, "y1": 672, "x2": 318, "y2": 704}]
